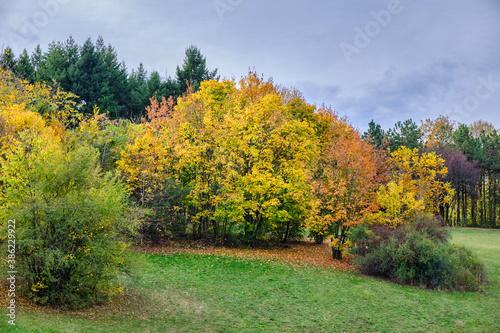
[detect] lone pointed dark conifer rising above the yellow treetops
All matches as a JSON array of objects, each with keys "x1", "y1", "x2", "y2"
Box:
[{"x1": 176, "y1": 45, "x2": 219, "y2": 93}]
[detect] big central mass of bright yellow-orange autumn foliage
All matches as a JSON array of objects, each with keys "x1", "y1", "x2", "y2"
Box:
[{"x1": 119, "y1": 73, "x2": 316, "y2": 243}]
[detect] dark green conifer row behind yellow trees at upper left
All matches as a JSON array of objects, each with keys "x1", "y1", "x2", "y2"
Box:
[{"x1": 0, "y1": 36, "x2": 218, "y2": 121}]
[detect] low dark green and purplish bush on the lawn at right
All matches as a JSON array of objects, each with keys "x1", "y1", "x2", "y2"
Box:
[{"x1": 354, "y1": 214, "x2": 486, "y2": 291}]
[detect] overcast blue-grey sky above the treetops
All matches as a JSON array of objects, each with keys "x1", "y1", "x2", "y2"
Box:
[{"x1": 0, "y1": 0, "x2": 500, "y2": 131}]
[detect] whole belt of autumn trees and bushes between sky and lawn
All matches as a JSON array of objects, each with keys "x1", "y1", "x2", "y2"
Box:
[{"x1": 0, "y1": 37, "x2": 500, "y2": 305}]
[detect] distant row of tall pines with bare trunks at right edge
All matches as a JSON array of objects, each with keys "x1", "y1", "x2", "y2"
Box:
[{"x1": 363, "y1": 115, "x2": 500, "y2": 227}]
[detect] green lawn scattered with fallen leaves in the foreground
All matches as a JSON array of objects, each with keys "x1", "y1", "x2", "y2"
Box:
[{"x1": 0, "y1": 229, "x2": 500, "y2": 332}]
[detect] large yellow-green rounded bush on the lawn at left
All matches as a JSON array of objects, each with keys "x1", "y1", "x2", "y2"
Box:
[{"x1": 1, "y1": 132, "x2": 137, "y2": 307}]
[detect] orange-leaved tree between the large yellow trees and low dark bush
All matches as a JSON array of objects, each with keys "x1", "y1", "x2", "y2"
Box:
[{"x1": 306, "y1": 114, "x2": 378, "y2": 259}]
